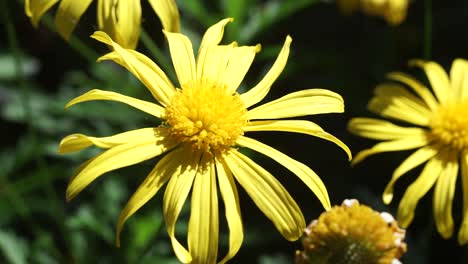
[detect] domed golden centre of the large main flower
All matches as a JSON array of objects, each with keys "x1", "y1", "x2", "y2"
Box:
[{"x1": 165, "y1": 80, "x2": 248, "y2": 152}]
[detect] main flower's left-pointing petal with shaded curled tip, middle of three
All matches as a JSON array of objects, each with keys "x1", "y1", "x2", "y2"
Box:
[{"x1": 58, "y1": 127, "x2": 160, "y2": 154}]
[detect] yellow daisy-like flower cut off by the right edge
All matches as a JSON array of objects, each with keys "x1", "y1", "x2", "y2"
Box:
[{"x1": 349, "y1": 59, "x2": 468, "y2": 245}]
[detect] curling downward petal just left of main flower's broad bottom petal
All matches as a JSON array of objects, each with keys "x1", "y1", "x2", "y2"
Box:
[{"x1": 163, "y1": 149, "x2": 200, "y2": 263}]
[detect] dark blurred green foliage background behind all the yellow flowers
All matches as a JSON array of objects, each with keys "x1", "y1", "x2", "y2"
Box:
[{"x1": 0, "y1": 0, "x2": 468, "y2": 264}]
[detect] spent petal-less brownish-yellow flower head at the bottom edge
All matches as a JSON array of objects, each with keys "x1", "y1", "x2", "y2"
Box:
[{"x1": 296, "y1": 199, "x2": 406, "y2": 264}]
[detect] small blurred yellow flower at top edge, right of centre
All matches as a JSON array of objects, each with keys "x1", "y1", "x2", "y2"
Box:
[{"x1": 337, "y1": 0, "x2": 409, "y2": 25}]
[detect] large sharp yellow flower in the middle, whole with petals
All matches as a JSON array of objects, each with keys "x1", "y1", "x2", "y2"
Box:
[{"x1": 59, "y1": 19, "x2": 350, "y2": 263}]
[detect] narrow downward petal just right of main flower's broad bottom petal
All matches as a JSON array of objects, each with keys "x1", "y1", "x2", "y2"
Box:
[{"x1": 216, "y1": 157, "x2": 244, "y2": 264}]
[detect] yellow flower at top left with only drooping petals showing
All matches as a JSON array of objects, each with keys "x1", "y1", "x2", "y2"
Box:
[{"x1": 25, "y1": 0, "x2": 179, "y2": 49}]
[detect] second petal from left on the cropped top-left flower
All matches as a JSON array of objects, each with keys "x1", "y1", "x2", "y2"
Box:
[{"x1": 55, "y1": 0, "x2": 93, "y2": 40}]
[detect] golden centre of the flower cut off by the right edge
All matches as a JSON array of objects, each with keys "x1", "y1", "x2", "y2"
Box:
[{"x1": 430, "y1": 101, "x2": 468, "y2": 150}]
